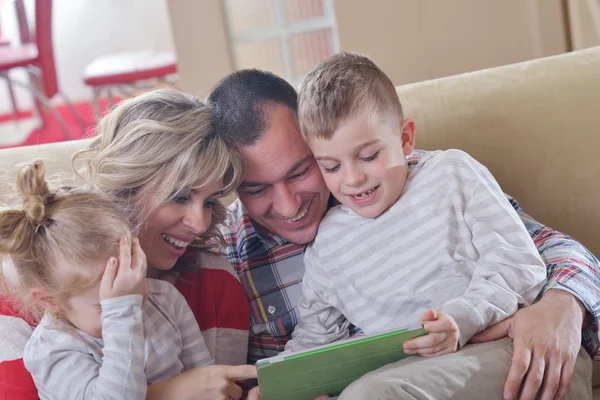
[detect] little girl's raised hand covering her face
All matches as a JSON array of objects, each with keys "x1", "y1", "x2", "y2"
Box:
[{"x1": 100, "y1": 237, "x2": 147, "y2": 300}]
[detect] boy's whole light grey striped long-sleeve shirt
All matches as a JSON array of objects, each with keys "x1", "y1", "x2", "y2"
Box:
[{"x1": 285, "y1": 150, "x2": 546, "y2": 351}]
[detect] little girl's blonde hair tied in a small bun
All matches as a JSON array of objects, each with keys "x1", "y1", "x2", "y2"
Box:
[{"x1": 0, "y1": 161, "x2": 129, "y2": 317}]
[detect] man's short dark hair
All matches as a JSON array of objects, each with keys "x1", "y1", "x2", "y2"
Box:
[{"x1": 207, "y1": 69, "x2": 298, "y2": 147}]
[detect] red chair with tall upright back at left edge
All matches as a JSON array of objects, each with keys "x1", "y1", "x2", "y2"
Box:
[{"x1": 0, "y1": 0, "x2": 84, "y2": 139}]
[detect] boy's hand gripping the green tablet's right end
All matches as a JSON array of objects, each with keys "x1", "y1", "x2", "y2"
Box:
[{"x1": 403, "y1": 310, "x2": 458, "y2": 357}]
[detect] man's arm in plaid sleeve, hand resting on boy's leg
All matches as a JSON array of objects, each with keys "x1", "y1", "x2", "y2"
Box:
[{"x1": 472, "y1": 197, "x2": 600, "y2": 400}]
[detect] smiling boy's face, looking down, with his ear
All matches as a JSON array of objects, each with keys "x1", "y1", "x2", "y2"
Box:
[{"x1": 308, "y1": 115, "x2": 415, "y2": 218}]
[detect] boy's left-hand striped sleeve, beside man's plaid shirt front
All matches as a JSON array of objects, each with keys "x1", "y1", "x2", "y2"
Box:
[{"x1": 285, "y1": 250, "x2": 350, "y2": 353}]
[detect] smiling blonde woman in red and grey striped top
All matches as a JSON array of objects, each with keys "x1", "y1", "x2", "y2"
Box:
[{"x1": 0, "y1": 90, "x2": 255, "y2": 400}]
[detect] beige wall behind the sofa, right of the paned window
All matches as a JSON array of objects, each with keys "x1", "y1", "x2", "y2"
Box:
[{"x1": 334, "y1": 0, "x2": 568, "y2": 85}]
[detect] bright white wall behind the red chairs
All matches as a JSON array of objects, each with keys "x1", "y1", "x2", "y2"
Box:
[{"x1": 0, "y1": 0, "x2": 173, "y2": 114}]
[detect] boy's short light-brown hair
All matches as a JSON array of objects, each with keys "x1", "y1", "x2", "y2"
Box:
[{"x1": 298, "y1": 52, "x2": 403, "y2": 139}]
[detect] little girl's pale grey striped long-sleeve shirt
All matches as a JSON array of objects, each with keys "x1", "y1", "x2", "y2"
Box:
[{"x1": 23, "y1": 279, "x2": 214, "y2": 400}]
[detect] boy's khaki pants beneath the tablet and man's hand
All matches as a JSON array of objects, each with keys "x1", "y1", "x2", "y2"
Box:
[{"x1": 339, "y1": 338, "x2": 592, "y2": 400}]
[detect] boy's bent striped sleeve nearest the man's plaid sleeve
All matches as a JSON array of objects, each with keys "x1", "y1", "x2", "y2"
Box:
[{"x1": 440, "y1": 153, "x2": 546, "y2": 346}]
